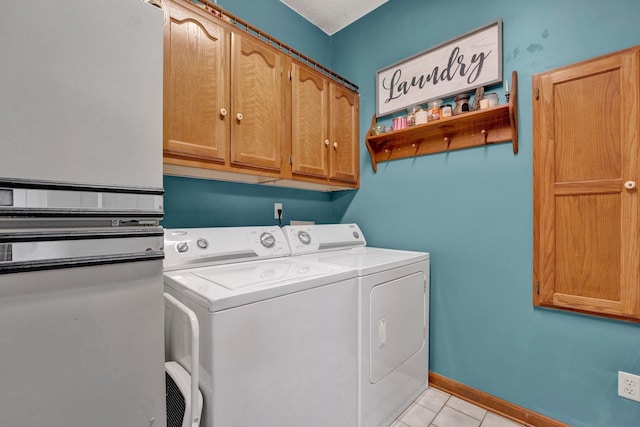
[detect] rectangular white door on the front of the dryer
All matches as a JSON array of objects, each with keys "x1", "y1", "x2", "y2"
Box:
[{"x1": 369, "y1": 271, "x2": 427, "y2": 384}]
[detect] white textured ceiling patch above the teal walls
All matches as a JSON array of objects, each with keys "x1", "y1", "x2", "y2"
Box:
[{"x1": 280, "y1": 0, "x2": 388, "y2": 35}]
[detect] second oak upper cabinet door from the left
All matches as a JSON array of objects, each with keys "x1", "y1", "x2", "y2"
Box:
[{"x1": 231, "y1": 33, "x2": 286, "y2": 171}]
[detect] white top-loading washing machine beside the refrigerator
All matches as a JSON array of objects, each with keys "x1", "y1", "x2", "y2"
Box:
[{"x1": 164, "y1": 227, "x2": 358, "y2": 427}]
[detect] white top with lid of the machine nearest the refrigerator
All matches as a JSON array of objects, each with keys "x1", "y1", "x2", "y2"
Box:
[{"x1": 164, "y1": 257, "x2": 356, "y2": 312}]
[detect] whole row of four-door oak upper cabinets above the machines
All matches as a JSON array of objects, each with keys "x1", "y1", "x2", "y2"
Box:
[{"x1": 163, "y1": 0, "x2": 359, "y2": 191}]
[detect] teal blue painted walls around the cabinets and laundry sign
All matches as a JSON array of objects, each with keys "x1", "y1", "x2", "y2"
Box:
[{"x1": 165, "y1": 0, "x2": 640, "y2": 427}]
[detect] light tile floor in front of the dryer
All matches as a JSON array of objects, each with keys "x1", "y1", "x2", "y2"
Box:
[{"x1": 390, "y1": 388, "x2": 523, "y2": 427}]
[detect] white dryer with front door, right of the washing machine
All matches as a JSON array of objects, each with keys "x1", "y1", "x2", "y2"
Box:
[{"x1": 284, "y1": 224, "x2": 430, "y2": 427}]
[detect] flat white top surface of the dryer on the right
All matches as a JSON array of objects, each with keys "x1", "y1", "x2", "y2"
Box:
[{"x1": 299, "y1": 247, "x2": 429, "y2": 276}]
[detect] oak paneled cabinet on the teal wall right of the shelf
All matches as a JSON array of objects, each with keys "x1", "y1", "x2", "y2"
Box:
[{"x1": 533, "y1": 48, "x2": 640, "y2": 321}]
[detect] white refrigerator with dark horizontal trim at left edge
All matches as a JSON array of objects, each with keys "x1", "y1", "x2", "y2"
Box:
[{"x1": 0, "y1": 0, "x2": 166, "y2": 427}]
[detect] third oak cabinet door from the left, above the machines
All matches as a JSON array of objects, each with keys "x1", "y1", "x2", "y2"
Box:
[{"x1": 291, "y1": 64, "x2": 330, "y2": 178}]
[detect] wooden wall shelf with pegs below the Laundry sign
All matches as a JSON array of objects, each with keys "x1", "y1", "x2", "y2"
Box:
[{"x1": 366, "y1": 71, "x2": 518, "y2": 172}]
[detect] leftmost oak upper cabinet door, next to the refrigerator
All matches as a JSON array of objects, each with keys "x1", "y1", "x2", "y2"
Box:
[{"x1": 163, "y1": 1, "x2": 229, "y2": 163}]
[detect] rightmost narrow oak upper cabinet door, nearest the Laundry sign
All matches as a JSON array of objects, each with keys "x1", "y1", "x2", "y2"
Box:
[{"x1": 329, "y1": 83, "x2": 360, "y2": 183}]
